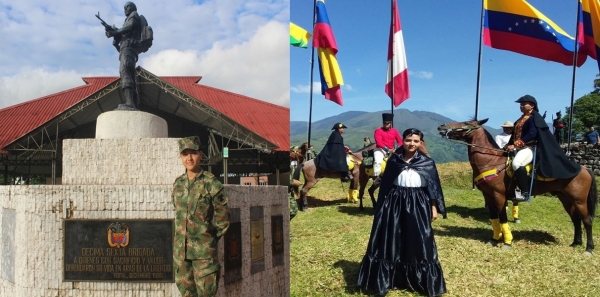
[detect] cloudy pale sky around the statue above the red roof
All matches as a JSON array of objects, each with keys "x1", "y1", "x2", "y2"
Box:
[{"x1": 0, "y1": 0, "x2": 290, "y2": 109}]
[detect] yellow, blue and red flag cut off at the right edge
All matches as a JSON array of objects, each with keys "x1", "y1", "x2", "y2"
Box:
[{"x1": 579, "y1": 0, "x2": 600, "y2": 69}]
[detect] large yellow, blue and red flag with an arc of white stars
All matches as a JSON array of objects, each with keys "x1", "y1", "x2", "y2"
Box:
[{"x1": 483, "y1": 0, "x2": 587, "y2": 66}]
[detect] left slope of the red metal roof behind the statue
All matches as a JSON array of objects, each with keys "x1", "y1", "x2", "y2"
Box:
[{"x1": 0, "y1": 77, "x2": 118, "y2": 152}]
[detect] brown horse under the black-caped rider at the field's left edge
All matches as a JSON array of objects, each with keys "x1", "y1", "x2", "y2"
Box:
[{"x1": 292, "y1": 148, "x2": 364, "y2": 211}]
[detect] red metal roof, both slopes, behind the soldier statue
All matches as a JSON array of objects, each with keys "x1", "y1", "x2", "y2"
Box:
[{"x1": 0, "y1": 76, "x2": 290, "y2": 152}]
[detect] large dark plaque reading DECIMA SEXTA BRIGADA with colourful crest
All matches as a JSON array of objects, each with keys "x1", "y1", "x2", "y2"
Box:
[{"x1": 63, "y1": 220, "x2": 174, "y2": 282}]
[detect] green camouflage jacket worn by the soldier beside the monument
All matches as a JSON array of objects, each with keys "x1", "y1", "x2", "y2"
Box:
[{"x1": 171, "y1": 170, "x2": 229, "y2": 266}]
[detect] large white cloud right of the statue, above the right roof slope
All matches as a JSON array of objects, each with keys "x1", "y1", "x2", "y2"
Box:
[{"x1": 140, "y1": 21, "x2": 290, "y2": 106}]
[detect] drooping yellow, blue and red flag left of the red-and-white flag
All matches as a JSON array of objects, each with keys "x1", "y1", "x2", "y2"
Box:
[{"x1": 313, "y1": 0, "x2": 344, "y2": 106}]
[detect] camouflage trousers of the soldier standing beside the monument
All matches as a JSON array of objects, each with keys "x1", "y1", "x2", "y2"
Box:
[{"x1": 173, "y1": 259, "x2": 219, "y2": 297}]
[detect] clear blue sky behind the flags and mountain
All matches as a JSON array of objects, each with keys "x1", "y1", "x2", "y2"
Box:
[{"x1": 290, "y1": 0, "x2": 598, "y2": 131}]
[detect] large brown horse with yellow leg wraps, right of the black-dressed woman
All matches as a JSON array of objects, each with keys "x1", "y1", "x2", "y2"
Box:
[{"x1": 438, "y1": 119, "x2": 598, "y2": 254}]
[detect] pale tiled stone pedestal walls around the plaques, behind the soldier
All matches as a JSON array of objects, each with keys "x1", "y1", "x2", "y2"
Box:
[{"x1": 0, "y1": 138, "x2": 290, "y2": 297}]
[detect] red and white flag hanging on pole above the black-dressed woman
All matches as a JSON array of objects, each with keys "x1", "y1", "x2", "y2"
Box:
[{"x1": 385, "y1": 0, "x2": 410, "y2": 107}]
